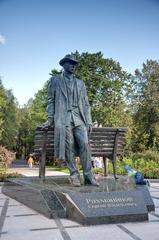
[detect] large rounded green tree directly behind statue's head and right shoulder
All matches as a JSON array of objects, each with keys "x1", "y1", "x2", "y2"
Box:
[{"x1": 74, "y1": 52, "x2": 131, "y2": 127}]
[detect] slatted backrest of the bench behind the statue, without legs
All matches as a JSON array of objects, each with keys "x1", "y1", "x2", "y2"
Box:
[{"x1": 34, "y1": 127, "x2": 126, "y2": 160}]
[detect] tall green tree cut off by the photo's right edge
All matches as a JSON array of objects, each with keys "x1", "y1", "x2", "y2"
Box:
[{"x1": 134, "y1": 60, "x2": 159, "y2": 150}]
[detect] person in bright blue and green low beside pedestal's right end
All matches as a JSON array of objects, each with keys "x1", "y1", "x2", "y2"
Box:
[{"x1": 125, "y1": 165, "x2": 150, "y2": 186}]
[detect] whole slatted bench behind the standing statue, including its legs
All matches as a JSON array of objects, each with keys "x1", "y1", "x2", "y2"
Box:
[{"x1": 34, "y1": 127, "x2": 126, "y2": 178}]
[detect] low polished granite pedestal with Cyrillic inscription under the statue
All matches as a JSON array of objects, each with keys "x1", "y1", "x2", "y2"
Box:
[{"x1": 2, "y1": 176, "x2": 154, "y2": 225}]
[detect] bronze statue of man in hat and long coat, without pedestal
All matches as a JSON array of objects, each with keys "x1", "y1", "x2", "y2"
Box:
[{"x1": 43, "y1": 55, "x2": 98, "y2": 186}]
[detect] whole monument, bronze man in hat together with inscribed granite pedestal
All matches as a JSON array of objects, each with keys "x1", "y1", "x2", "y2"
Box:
[{"x1": 2, "y1": 55, "x2": 154, "y2": 225}]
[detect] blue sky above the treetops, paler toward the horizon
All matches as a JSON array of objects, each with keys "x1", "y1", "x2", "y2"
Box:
[{"x1": 0, "y1": 0, "x2": 159, "y2": 105}]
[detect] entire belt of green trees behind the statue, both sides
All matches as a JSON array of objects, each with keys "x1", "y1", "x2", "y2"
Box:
[{"x1": 0, "y1": 55, "x2": 159, "y2": 159}]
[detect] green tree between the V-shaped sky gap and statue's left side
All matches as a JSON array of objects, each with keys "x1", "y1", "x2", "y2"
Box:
[{"x1": 16, "y1": 82, "x2": 47, "y2": 157}]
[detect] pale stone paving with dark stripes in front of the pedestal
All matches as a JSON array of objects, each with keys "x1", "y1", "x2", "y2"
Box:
[{"x1": 0, "y1": 159, "x2": 159, "y2": 240}]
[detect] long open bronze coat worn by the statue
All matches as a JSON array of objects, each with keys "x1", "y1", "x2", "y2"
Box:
[{"x1": 47, "y1": 75, "x2": 92, "y2": 160}]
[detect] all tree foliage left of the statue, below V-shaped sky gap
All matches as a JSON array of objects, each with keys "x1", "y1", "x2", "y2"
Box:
[{"x1": 0, "y1": 76, "x2": 47, "y2": 157}]
